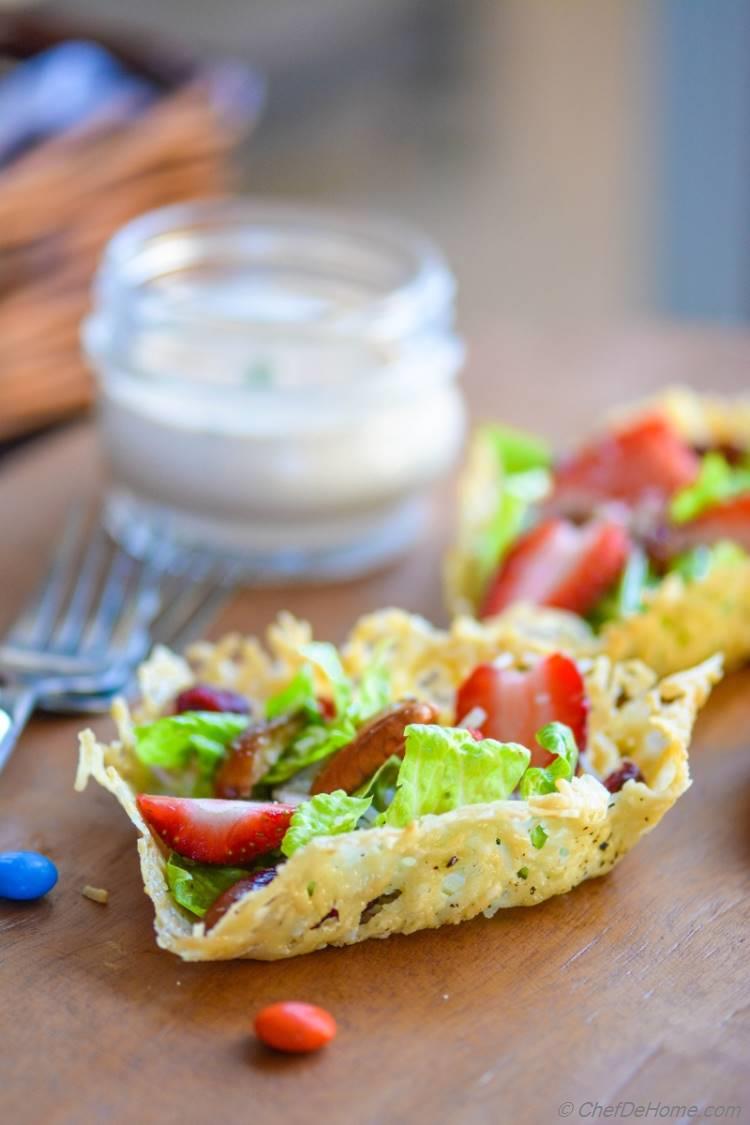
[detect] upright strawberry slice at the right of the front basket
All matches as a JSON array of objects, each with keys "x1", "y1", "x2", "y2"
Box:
[{"x1": 455, "y1": 653, "x2": 588, "y2": 766}]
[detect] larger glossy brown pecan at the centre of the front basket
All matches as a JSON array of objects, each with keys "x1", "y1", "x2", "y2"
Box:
[{"x1": 310, "y1": 700, "x2": 437, "y2": 795}]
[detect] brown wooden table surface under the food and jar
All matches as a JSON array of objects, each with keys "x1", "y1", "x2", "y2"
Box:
[{"x1": 0, "y1": 326, "x2": 750, "y2": 1125}]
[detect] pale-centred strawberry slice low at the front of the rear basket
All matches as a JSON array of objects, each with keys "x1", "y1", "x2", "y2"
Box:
[{"x1": 480, "y1": 520, "x2": 630, "y2": 618}]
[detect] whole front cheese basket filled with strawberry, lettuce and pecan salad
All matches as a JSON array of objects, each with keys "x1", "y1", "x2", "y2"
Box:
[{"x1": 78, "y1": 611, "x2": 720, "y2": 960}]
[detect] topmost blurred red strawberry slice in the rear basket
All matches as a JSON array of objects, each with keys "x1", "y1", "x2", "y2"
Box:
[{"x1": 550, "y1": 414, "x2": 701, "y2": 512}]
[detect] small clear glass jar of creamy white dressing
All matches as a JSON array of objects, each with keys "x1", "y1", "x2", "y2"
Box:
[{"x1": 83, "y1": 199, "x2": 464, "y2": 578}]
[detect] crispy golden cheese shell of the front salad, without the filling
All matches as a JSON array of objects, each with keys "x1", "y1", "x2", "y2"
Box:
[{"x1": 76, "y1": 610, "x2": 721, "y2": 961}]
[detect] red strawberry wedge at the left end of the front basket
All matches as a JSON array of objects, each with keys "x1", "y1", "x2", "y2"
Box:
[{"x1": 136, "y1": 793, "x2": 295, "y2": 865}]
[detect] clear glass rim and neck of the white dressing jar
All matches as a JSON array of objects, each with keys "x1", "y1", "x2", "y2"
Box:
[{"x1": 88, "y1": 197, "x2": 463, "y2": 402}]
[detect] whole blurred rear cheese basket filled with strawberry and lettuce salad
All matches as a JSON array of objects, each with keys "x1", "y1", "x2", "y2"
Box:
[{"x1": 446, "y1": 390, "x2": 750, "y2": 673}]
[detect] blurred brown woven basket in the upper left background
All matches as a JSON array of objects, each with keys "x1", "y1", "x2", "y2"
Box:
[{"x1": 0, "y1": 9, "x2": 262, "y2": 440}]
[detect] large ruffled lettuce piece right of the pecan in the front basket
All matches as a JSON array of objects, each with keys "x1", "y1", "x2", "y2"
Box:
[{"x1": 379, "y1": 723, "x2": 531, "y2": 828}]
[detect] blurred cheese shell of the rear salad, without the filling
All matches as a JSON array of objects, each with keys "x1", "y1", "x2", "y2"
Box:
[{"x1": 444, "y1": 388, "x2": 750, "y2": 675}]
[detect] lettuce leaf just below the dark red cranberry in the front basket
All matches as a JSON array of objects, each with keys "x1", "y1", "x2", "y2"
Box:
[{"x1": 135, "y1": 711, "x2": 250, "y2": 780}]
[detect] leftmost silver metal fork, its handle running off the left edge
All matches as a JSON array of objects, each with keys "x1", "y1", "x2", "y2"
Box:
[{"x1": 0, "y1": 510, "x2": 162, "y2": 771}]
